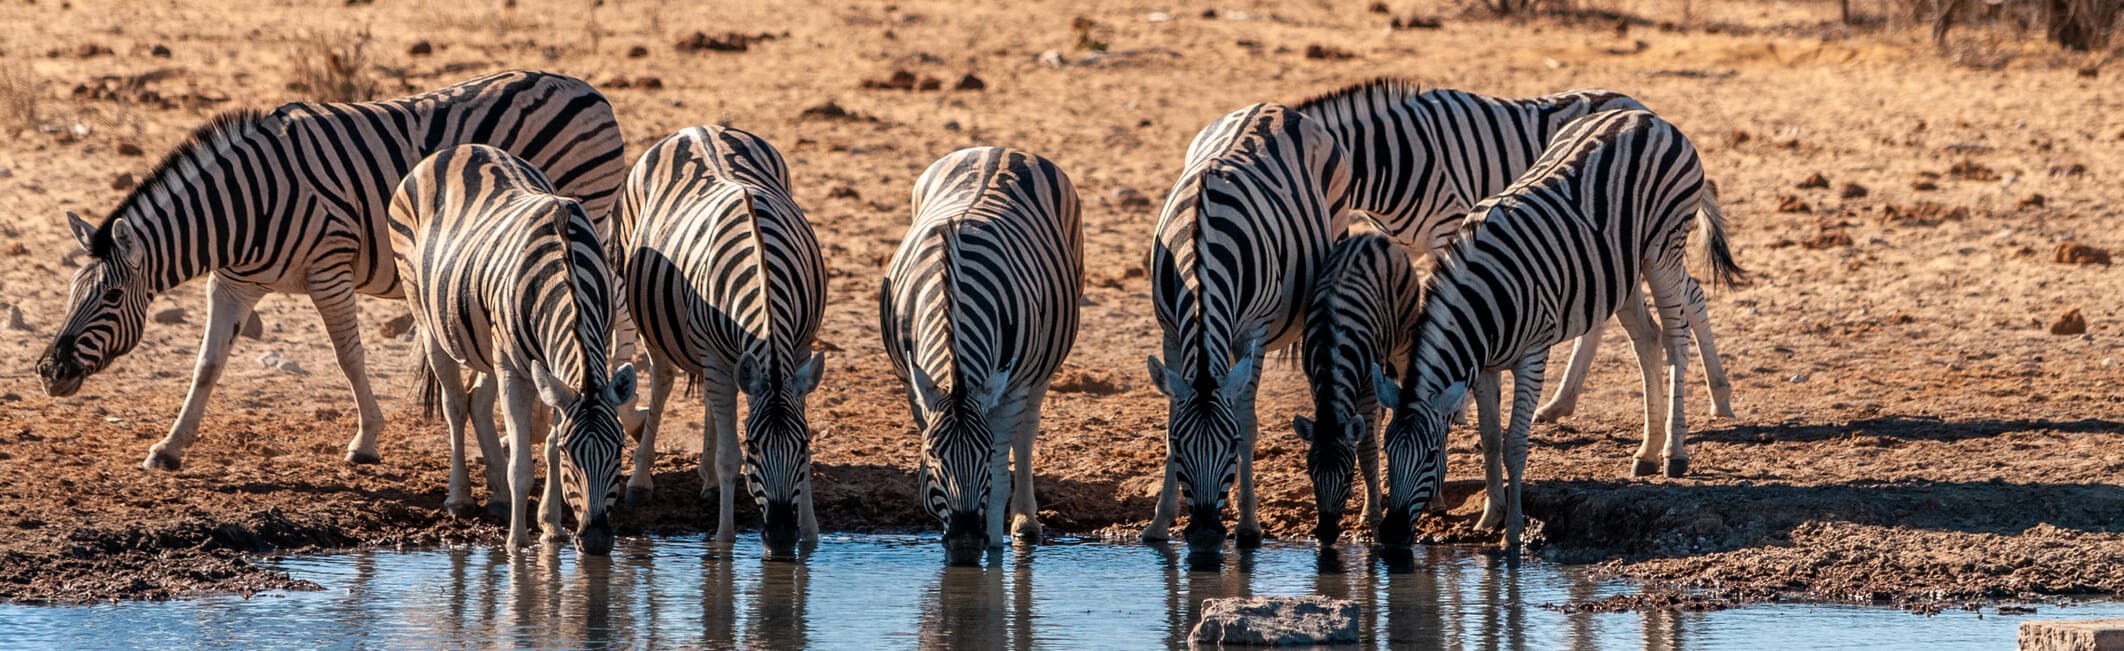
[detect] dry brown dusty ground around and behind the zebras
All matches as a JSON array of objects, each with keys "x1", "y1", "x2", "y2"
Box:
[{"x1": 0, "y1": 0, "x2": 2124, "y2": 606}]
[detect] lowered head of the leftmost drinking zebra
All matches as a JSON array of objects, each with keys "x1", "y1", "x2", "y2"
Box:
[{"x1": 531, "y1": 362, "x2": 635, "y2": 555}]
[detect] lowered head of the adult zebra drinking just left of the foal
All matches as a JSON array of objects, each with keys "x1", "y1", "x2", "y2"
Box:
[{"x1": 1149, "y1": 351, "x2": 1257, "y2": 553}]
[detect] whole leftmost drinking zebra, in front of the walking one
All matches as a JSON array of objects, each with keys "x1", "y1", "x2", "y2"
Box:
[{"x1": 387, "y1": 145, "x2": 635, "y2": 555}]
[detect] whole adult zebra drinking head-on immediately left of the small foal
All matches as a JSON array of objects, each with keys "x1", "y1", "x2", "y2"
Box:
[{"x1": 1143, "y1": 104, "x2": 1349, "y2": 553}]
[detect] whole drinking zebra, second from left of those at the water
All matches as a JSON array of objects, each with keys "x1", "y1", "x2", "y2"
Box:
[{"x1": 616, "y1": 126, "x2": 826, "y2": 555}]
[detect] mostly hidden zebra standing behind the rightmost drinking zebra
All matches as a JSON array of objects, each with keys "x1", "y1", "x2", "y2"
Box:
[{"x1": 1298, "y1": 77, "x2": 1733, "y2": 438}]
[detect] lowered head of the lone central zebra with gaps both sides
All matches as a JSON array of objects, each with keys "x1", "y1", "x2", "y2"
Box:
[{"x1": 911, "y1": 364, "x2": 1024, "y2": 566}]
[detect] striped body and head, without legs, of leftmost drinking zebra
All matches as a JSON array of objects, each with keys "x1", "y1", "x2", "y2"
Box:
[{"x1": 389, "y1": 145, "x2": 633, "y2": 525}]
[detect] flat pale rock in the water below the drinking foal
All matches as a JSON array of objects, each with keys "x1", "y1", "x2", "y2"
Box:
[{"x1": 1189, "y1": 596, "x2": 1357, "y2": 647}]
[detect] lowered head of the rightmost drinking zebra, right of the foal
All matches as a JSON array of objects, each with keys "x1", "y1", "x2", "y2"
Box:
[{"x1": 1372, "y1": 370, "x2": 1468, "y2": 549}]
